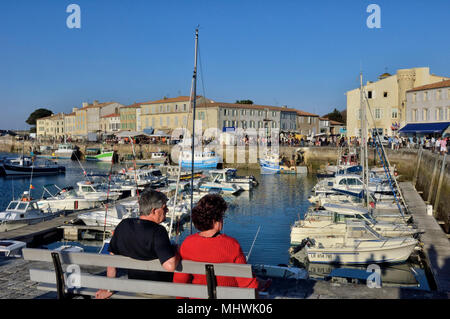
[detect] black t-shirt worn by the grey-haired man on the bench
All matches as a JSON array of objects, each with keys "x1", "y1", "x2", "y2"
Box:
[{"x1": 109, "y1": 218, "x2": 175, "y2": 281}]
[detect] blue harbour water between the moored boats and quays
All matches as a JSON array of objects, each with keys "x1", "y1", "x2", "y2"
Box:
[{"x1": 0, "y1": 154, "x2": 428, "y2": 289}]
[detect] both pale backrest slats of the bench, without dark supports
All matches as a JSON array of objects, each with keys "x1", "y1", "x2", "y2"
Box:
[{"x1": 22, "y1": 248, "x2": 256, "y2": 299}]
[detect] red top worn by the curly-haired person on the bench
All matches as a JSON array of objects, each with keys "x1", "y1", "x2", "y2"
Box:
[{"x1": 173, "y1": 234, "x2": 258, "y2": 288}]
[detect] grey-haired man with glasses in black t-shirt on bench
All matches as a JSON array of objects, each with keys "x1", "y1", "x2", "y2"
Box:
[{"x1": 95, "y1": 190, "x2": 180, "y2": 299}]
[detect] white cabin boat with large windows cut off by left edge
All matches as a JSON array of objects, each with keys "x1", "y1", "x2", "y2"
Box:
[{"x1": 0, "y1": 192, "x2": 60, "y2": 232}]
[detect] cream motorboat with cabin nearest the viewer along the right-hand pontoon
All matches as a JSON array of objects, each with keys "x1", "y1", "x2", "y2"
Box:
[{"x1": 305, "y1": 221, "x2": 418, "y2": 264}]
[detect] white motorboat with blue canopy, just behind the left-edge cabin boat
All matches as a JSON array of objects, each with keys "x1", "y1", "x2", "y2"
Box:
[{"x1": 37, "y1": 184, "x2": 102, "y2": 211}]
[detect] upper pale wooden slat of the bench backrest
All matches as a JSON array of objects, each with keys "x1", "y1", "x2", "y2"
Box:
[{"x1": 22, "y1": 248, "x2": 253, "y2": 278}]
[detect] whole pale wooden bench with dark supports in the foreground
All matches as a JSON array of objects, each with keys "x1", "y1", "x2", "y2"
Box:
[{"x1": 22, "y1": 248, "x2": 256, "y2": 299}]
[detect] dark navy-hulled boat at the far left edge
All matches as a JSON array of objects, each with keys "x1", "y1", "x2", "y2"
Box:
[{"x1": 3, "y1": 156, "x2": 66, "y2": 176}]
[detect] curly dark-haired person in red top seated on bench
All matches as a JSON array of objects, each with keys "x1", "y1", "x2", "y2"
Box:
[{"x1": 173, "y1": 194, "x2": 258, "y2": 300}]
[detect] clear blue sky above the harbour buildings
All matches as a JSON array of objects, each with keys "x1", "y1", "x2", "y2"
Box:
[{"x1": 0, "y1": 0, "x2": 450, "y2": 129}]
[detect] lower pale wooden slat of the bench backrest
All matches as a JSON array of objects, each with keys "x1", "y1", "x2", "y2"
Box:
[{"x1": 30, "y1": 269, "x2": 255, "y2": 299}]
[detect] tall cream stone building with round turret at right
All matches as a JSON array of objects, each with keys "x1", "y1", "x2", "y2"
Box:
[{"x1": 346, "y1": 67, "x2": 449, "y2": 137}]
